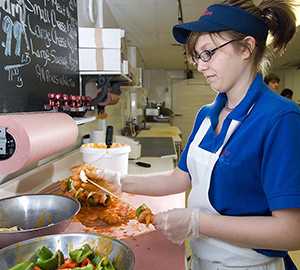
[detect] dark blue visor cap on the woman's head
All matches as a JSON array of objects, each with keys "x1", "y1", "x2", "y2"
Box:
[{"x1": 173, "y1": 4, "x2": 269, "y2": 44}]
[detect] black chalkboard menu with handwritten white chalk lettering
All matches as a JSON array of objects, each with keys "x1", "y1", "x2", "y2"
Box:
[{"x1": 0, "y1": 0, "x2": 79, "y2": 113}]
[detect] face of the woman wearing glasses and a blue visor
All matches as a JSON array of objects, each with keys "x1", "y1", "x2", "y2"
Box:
[{"x1": 195, "y1": 34, "x2": 249, "y2": 92}]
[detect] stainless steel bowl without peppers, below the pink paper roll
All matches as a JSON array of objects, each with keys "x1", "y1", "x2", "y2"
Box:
[{"x1": 0, "y1": 194, "x2": 80, "y2": 249}]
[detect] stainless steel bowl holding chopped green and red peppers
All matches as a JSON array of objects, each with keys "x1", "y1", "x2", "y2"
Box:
[{"x1": 0, "y1": 233, "x2": 135, "y2": 270}]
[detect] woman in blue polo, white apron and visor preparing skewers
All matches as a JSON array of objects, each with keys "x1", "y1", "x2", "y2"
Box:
[{"x1": 94, "y1": 0, "x2": 300, "y2": 270}]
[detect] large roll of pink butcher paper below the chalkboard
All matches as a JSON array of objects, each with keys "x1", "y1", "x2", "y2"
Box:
[{"x1": 0, "y1": 112, "x2": 78, "y2": 175}]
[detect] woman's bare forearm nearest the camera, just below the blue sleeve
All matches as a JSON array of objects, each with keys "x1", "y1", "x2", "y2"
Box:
[{"x1": 200, "y1": 209, "x2": 300, "y2": 250}]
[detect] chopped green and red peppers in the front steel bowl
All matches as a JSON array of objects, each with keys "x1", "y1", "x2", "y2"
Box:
[{"x1": 9, "y1": 244, "x2": 116, "y2": 270}]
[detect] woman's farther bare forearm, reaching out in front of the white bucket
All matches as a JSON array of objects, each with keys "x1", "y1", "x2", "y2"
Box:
[{"x1": 121, "y1": 169, "x2": 190, "y2": 196}]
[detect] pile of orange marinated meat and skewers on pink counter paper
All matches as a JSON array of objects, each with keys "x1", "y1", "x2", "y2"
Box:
[{"x1": 60, "y1": 164, "x2": 135, "y2": 226}]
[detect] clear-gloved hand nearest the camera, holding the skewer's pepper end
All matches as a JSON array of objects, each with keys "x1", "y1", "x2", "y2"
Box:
[{"x1": 154, "y1": 208, "x2": 201, "y2": 244}]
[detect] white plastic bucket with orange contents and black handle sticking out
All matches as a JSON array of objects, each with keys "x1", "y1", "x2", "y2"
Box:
[{"x1": 80, "y1": 143, "x2": 131, "y2": 175}]
